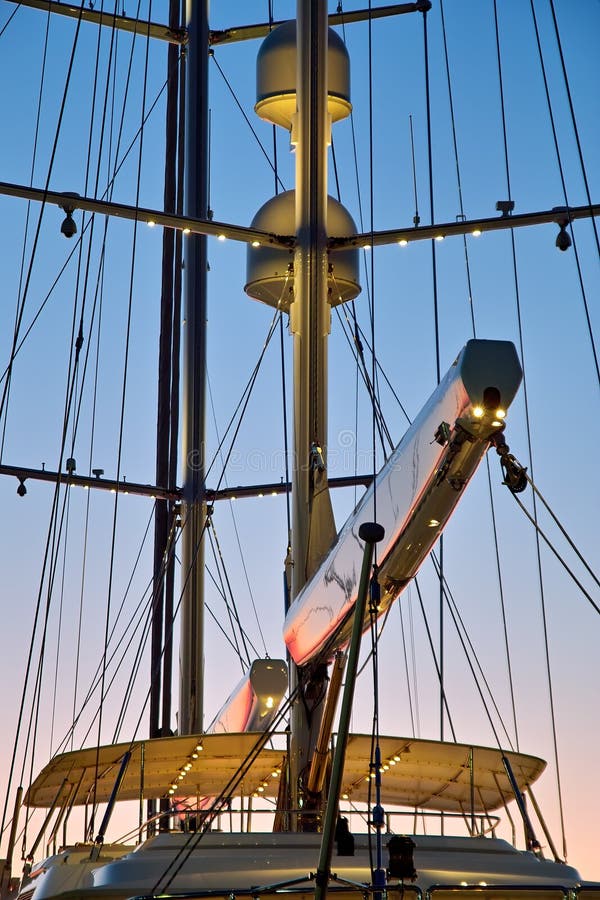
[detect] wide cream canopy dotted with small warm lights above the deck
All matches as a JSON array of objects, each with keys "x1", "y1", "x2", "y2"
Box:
[{"x1": 25, "y1": 733, "x2": 546, "y2": 813}]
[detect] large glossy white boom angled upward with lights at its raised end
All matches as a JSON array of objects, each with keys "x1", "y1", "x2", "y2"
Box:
[{"x1": 284, "y1": 340, "x2": 522, "y2": 665}]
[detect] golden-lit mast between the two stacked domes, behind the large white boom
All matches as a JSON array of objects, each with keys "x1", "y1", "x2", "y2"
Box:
[{"x1": 290, "y1": 0, "x2": 335, "y2": 828}]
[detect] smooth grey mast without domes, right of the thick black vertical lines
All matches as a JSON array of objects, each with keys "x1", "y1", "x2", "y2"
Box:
[{"x1": 179, "y1": 0, "x2": 209, "y2": 734}]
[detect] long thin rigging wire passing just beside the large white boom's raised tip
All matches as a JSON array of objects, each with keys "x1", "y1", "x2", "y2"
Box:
[{"x1": 493, "y1": 0, "x2": 567, "y2": 859}]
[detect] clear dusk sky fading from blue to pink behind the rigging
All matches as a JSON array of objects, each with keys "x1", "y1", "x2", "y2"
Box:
[{"x1": 0, "y1": 0, "x2": 600, "y2": 879}]
